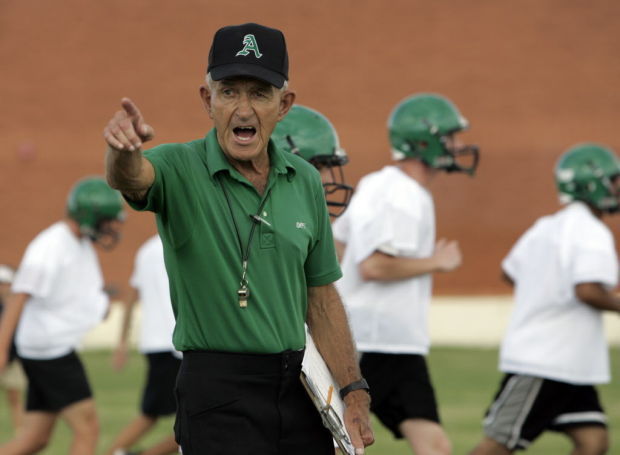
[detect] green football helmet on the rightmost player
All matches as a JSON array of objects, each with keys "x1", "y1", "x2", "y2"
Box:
[{"x1": 555, "y1": 143, "x2": 620, "y2": 213}]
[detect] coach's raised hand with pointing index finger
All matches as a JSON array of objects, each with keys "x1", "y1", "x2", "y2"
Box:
[{"x1": 103, "y1": 98, "x2": 155, "y2": 152}]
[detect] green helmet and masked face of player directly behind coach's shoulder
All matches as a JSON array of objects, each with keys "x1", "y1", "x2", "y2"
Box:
[{"x1": 271, "y1": 104, "x2": 353, "y2": 217}]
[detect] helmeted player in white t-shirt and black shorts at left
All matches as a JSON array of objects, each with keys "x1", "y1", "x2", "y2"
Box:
[{"x1": 0, "y1": 178, "x2": 123, "y2": 455}]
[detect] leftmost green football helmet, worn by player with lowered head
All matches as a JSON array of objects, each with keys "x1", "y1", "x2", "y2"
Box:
[{"x1": 67, "y1": 177, "x2": 125, "y2": 248}]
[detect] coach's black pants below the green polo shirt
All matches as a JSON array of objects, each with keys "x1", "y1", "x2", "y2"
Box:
[{"x1": 174, "y1": 351, "x2": 334, "y2": 455}]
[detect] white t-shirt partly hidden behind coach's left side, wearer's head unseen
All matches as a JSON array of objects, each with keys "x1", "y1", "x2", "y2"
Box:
[{"x1": 130, "y1": 235, "x2": 175, "y2": 354}]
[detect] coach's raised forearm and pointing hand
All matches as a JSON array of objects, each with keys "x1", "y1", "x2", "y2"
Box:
[{"x1": 103, "y1": 98, "x2": 155, "y2": 201}]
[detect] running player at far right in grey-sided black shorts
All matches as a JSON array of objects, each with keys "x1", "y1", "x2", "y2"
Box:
[{"x1": 471, "y1": 143, "x2": 620, "y2": 455}]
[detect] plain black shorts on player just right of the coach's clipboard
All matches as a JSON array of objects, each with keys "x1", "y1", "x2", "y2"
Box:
[{"x1": 360, "y1": 352, "x2": 440, "y2": 439}]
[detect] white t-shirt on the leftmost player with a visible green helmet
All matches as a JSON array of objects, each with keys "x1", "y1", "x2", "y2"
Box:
[{"x1": 12, "y1": 221, "x2": 108, "y2": 359}]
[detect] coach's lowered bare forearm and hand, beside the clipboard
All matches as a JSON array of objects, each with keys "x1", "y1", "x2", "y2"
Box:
[{"x1": 306, "y1": 284, "x2": 374, "y2": 453}]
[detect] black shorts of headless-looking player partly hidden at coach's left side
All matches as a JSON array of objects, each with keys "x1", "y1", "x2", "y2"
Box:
[{"x1": 141, "y1": 351, "x2": 181, "y2": 417}]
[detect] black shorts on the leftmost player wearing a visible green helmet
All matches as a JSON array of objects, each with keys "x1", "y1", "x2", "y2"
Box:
[{"x1": 20, "y1": 351, "x2": 93, "y2": 413}]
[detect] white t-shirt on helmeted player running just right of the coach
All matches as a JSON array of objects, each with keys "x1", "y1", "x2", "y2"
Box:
[{"x1": 333, "y1": 166, "x2": 435, "y2": 354}]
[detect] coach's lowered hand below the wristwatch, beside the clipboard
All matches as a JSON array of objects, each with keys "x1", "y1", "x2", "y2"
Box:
[{"x1": 344, "y1": 390, "x2": 375, "y2": 455}]
